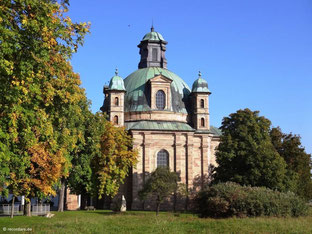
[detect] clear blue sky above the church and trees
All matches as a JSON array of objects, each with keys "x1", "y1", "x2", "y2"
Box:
[{"x1": 64, "y1": 0, "x2": 312, "y2": 153}]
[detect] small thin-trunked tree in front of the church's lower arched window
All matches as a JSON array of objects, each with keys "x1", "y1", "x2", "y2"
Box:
[{"x1": 139, "y1": 167, "x2": 179, "y2": 215}]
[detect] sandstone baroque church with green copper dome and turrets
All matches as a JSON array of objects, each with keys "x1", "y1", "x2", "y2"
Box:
[{"x1": 101, "y1": 27, "x2": 221, "y2": 209}]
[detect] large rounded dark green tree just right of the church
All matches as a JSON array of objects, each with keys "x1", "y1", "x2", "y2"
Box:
[{"x1": 214, "y1": 109, "x2": 293, "y2": 191}]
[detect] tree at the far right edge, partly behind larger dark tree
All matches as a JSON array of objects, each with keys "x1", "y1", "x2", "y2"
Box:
[{"x1": 270, "y1": 127, "x2": 312, "y2": 200}]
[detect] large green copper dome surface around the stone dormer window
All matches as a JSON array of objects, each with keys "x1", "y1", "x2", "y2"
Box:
[{"x1": 124, "y1": 67, "x2": 190, "y2": 113}]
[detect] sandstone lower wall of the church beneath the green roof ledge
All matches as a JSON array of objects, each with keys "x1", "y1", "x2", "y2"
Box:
[{"x1": 131, "y1": 131, "x2": 217, "y2": 209}]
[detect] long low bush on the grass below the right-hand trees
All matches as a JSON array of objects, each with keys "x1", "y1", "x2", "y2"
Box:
[{"x1": 195, "y1": 182, "x2": 308, "y2": 218}]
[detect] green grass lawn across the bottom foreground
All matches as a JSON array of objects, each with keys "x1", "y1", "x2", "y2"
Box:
[{"x1": 0, "y1": 210, "x2": 312, "y2": 234}]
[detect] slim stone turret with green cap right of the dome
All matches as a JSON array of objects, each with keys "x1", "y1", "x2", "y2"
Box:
[{"x1": 191, "y1": 72, "x2": 211, "y2": 131}]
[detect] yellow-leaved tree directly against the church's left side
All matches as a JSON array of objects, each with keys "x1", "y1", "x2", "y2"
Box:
[{"x1": 91, "y1": 118, "x2": 138, "y2": 198}]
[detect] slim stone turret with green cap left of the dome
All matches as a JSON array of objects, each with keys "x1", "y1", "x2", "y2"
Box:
[{"x1": 104, "y1": 69, "x2": 126, "y2": 127}]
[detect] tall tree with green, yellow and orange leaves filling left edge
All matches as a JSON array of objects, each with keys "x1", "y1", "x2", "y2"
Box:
[{"x1": 0, "y1": 0, "x2": 89, "y2": 216}]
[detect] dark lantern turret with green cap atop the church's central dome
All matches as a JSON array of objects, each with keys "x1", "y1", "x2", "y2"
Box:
[{"x1": 138, "y1": 26, "x2": 167, "y2": 69}]
